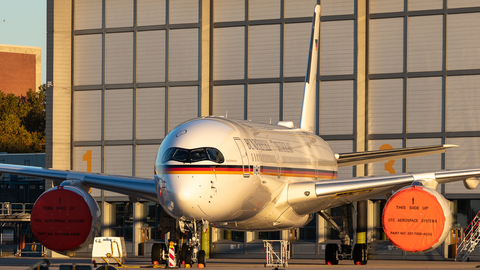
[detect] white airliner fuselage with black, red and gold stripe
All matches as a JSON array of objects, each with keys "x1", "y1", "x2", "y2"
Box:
[{"x1": 155, "y1": 117, "x2": 337, "y2": 230}]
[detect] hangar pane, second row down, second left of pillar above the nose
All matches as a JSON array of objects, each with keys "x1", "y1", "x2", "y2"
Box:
[{"x1": 136, "y1": 30, "x2": 165, "y2": 82}]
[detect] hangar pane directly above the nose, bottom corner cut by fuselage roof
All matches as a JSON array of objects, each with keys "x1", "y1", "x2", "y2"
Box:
[{"x1": 168, "y1": 86, "x2": 198, "y2": 131}]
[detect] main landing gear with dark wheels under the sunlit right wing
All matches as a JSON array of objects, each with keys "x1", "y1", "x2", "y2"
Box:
[{"x1": 318, "y1": 205, "x2": 368, "y2": 265}]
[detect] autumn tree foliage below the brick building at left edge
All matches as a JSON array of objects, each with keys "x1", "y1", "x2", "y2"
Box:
[{"x1": 0, "y1": 84, "x2": 46, "y2": 153}]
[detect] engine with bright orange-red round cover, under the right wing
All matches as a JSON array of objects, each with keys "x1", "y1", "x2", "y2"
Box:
[{"x1": 382, "y1": 186, "x2": 452, "y2": 252}]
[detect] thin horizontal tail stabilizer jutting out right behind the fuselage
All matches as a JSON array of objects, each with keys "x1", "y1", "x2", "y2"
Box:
[{"x1": 335, "y1": 144, "x2": 458, "y2": 167}]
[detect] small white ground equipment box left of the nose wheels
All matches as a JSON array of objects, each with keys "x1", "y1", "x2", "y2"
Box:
[{"x1": 92, "y1": 237, "x2": 127, "y2": 264}]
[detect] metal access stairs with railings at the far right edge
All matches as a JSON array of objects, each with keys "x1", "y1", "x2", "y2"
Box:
[{"x1": 455, "y1": 211, "x2": 480, "y2": 262}]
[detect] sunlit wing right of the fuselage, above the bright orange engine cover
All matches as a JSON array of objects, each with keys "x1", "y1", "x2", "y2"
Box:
[{"x1": 288, "y1": 168, "x2": 480, "y2": 214}]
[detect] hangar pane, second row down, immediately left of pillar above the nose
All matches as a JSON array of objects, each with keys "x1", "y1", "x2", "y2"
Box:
[{"x1": 168, "y1": 28, "x2": 199, "y2": 81}]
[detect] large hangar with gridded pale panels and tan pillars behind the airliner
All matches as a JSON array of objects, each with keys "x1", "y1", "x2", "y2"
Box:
[{"x1": 46, "y1": 0, "x2": 480, "y2": 258}]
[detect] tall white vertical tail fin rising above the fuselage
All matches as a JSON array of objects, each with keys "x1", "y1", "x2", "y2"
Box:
[{"x1": 300, "y1": 5, "x2": 320, "y2": 132}]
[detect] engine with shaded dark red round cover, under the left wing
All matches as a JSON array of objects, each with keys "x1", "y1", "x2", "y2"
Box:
[{"x1": 31, "y1": 186, "x2": 100, "y2": 253}]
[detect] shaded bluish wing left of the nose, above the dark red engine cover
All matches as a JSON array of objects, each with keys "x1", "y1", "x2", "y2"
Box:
[{"x1": 0, "y1": 164, "x2": 158, "y2": 202}]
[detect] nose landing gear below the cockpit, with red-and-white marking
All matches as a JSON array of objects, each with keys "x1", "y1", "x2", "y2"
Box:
[{"x1": 151, "y1": 210, "x2": 208, "y2": 268}]
